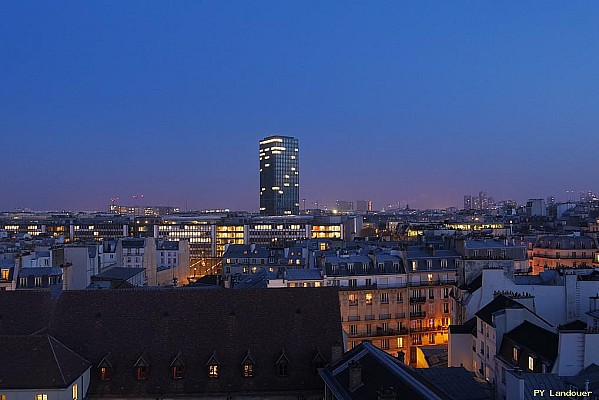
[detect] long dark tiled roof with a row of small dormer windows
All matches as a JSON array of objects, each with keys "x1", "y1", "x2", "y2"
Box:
[{"x1": 0, "y1": 288, "x2": 342, "y2": 397}]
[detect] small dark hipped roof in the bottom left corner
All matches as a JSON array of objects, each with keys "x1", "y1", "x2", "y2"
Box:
[{"x1": 0, "y1": 335, "x2": 91, "y2": 389}]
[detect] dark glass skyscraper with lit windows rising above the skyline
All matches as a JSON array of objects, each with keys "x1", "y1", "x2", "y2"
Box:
[{"x1": 260, "y1": 136, "x2": 299, "y2": 215}]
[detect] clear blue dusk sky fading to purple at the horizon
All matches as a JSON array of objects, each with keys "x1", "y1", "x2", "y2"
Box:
[{"x1": 0, "y1": 1, "x2": 599, "y2": 210}]
